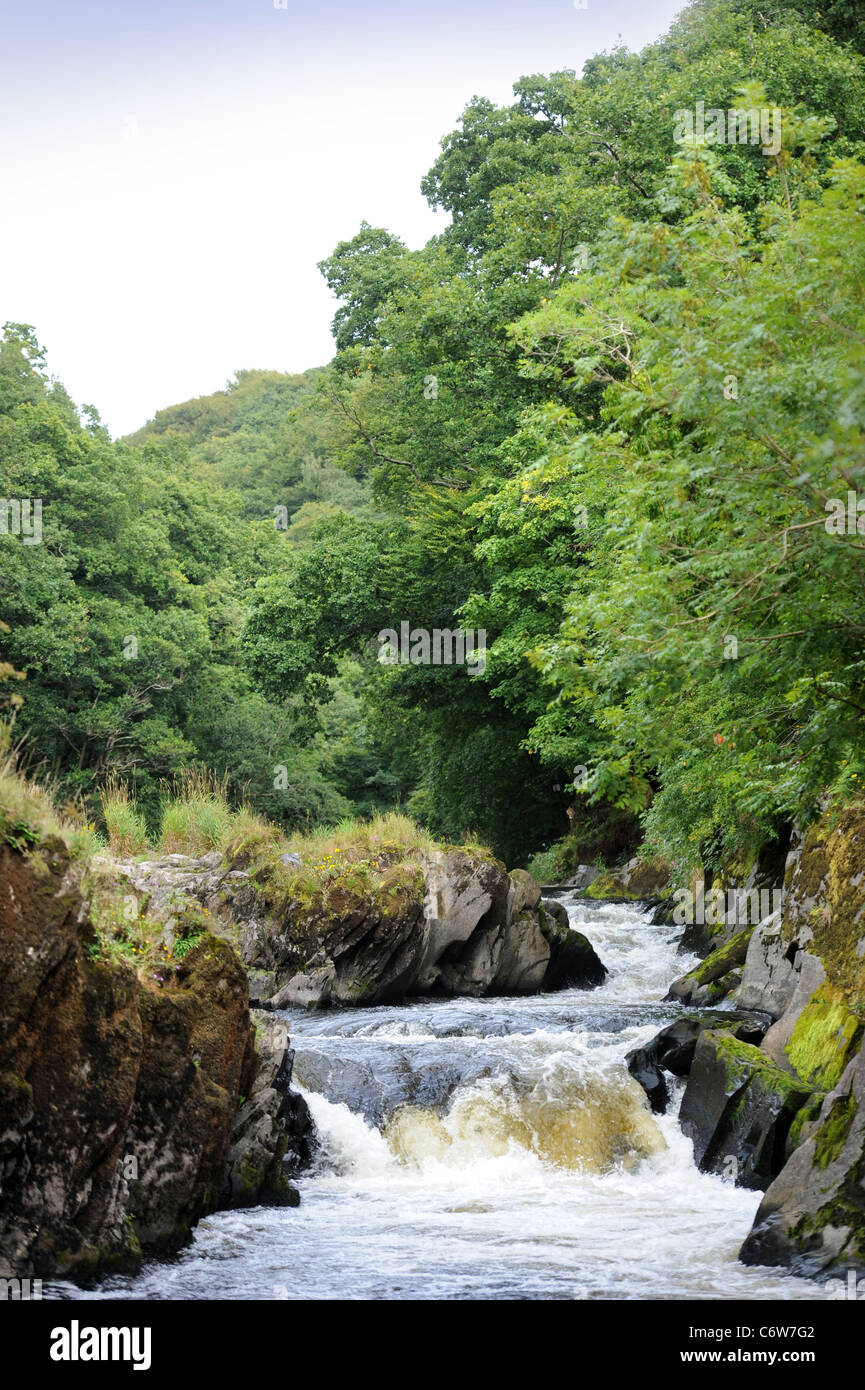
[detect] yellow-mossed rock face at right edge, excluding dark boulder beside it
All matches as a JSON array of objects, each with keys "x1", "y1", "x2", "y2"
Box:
[{"x1": 740, "y1": 810, "x2": 865, "y2": 1275}]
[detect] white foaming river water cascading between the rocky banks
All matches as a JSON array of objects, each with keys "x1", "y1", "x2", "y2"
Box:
[{"x1": 53, "y1": 898, "x2": 819, "y2": 1300}]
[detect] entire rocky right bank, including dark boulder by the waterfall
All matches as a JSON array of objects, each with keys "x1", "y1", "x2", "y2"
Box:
[{"x1": 630, "y1": 810, "x2": 865, "y2": 1277}]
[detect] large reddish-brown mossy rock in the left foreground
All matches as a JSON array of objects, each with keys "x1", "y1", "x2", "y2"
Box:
[{"x1": 0, "y1": 840, "x2": 311, "y2": 1280}]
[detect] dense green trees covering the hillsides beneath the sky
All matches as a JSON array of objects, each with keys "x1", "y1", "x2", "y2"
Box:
[{"x1": 0, "y1": 0, "x2": 865, "y2": 872}]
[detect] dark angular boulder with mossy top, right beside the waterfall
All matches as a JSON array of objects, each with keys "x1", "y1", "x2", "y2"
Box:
[{"x1": 679, "y1": 1029, "x2": 812, "y2": 1188}]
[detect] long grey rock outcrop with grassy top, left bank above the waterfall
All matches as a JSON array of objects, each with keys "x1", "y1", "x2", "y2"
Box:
[{"x1": 116, "y1": 849, "x2": 606, "y2": 1011}]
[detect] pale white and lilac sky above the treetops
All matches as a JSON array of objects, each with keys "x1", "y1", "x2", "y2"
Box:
[{"x1": 0, "y1": 0, "x2": 684, "y2": 435}]
